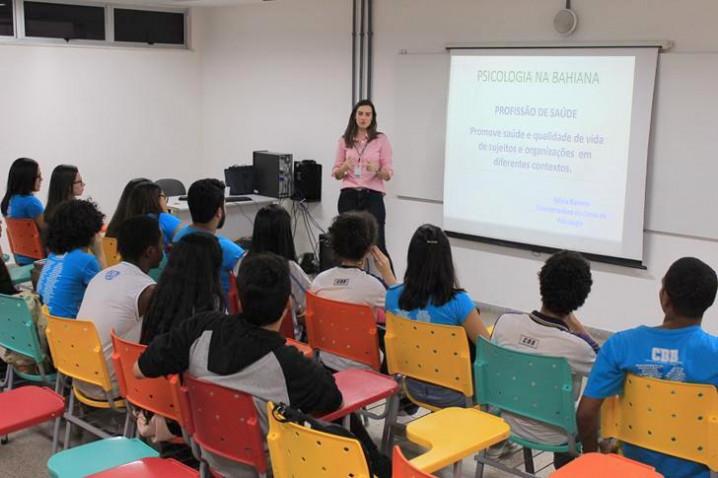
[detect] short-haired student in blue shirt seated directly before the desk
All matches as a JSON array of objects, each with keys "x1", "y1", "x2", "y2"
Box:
[{"x1": 174, "y1": 179, "x2": 244, "y2": 296}]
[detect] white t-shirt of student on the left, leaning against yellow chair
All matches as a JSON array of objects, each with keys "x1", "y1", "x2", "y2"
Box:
[{"x1": 77, "y1": 262, "x2": 155, "y2": 399}]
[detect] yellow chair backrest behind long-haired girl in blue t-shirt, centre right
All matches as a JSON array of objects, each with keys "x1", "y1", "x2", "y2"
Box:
[{"x1": 384, "y1": 312, "x2": 474, "y2": 397}]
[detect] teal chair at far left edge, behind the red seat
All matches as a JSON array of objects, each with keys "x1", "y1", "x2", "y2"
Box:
[{"x1": 0, "y1": 294, "x2": 57, "y2": 390}]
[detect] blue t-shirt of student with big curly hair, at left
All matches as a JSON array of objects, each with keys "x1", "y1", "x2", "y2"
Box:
[{"x1": 37, "y1": 249, "x2": 100, "y2": 319}]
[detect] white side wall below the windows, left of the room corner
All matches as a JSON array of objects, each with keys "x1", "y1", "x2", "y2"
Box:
[{"x1": 0, "y1": 22, "x2": 202, "y2": 251}]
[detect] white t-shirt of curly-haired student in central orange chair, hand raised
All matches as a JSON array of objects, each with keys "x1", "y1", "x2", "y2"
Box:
[{"x1": 311, "y1": 266, "x2": 386, "y2": 371}]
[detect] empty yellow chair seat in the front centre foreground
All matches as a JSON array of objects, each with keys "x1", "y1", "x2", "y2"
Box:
[{"x1": 406, "y1": 407, "x2": 511, "y2": 473}]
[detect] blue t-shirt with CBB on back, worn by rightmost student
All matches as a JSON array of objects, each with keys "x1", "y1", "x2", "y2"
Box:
[{"x1": 584, "y1": 325, "x2": 718, "y2": 478}]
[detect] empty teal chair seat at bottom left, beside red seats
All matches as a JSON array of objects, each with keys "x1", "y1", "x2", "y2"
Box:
[{"x1": 47, "y1": 437, "x2": 159, "y2": 478}]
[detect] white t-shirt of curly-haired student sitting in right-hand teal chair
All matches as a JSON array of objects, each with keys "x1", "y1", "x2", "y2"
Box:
[{"x1": 491, "y1": 312, "x2": 596, "y2": 445}]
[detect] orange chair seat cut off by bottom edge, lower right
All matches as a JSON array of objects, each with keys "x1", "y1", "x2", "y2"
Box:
[{"x1": 549, "y1": 453, "x2": 661, "y2": 478}]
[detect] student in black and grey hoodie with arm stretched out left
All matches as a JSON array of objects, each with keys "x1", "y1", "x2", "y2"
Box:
[{"x1": 135, "y1": 252, "x2": 342, "y2": 477}]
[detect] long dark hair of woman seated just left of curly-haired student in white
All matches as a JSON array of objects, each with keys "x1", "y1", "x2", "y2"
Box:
[{"x1": 251, "y1": 204, "x2": 297, "y2": 262}]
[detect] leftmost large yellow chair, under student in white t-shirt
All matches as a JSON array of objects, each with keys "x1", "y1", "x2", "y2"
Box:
[{"x1": 42, "y1": 307, "x2": 129, "y2": 453}]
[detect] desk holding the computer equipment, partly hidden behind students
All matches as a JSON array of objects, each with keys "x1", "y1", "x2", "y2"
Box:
[{"x1": 167, "y1": 194, "x2": 279, "y2": 241}]
